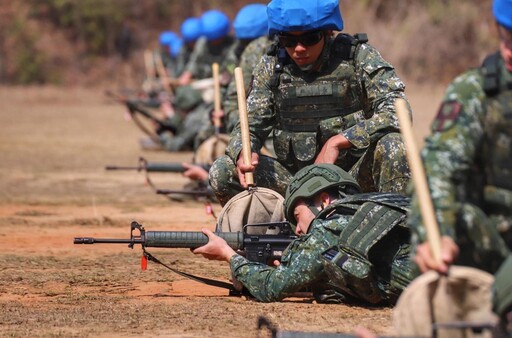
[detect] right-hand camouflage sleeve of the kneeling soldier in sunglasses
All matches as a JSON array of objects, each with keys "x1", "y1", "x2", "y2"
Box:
[{"x1": 342, "y1": 44, "x2": 406, "y2": 148}]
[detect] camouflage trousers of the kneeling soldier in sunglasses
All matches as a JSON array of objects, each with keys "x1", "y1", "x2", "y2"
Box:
[{"x1": 210, "y1": 133, "x2": 410, "y2": 205}]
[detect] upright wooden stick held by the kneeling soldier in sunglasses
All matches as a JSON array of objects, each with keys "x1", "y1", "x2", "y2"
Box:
[{"x1": 235, "y1": 67, "x2": 254, "y2": 187}]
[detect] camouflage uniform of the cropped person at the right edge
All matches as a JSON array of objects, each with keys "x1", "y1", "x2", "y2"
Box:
[{"x1": 409, "y1": 53, "x2": 512, "y2": 273}]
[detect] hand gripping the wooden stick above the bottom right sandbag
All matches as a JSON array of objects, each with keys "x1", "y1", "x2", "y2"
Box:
[{"x1": 414, "y1": 236, "x2": 459, "y2": 274}]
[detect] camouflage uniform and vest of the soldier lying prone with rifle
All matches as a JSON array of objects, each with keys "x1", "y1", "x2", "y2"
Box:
[{"x1": 230, "y1": 193, "x2": 412, "y2": 304}]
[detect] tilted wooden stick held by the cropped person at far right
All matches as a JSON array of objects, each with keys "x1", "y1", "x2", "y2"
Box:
[{"x1": 395, "y1": 99, "x2": 441, "y2": 265}]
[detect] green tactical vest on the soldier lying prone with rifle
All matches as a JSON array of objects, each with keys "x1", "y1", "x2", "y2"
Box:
[{"x1": 317, "y1": 193, "x2": 411, "y2": 304}]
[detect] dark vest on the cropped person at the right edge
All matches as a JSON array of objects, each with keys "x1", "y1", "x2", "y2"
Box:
[{"x1": 481, "y1": 52, "x2": 512, "y2": 216}]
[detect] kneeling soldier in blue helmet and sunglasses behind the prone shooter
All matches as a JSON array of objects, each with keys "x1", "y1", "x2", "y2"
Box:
[{"x1": 210, "y1": 0, "x2": 410, "y2": 204}]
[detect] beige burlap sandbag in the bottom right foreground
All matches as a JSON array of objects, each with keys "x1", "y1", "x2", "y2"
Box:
[{"x1": 393, "y1": 266, "x2": 496, "y2": 338}]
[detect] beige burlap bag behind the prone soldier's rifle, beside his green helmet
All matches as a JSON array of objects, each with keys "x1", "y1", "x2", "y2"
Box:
[{"x1": 215, "y1": 187, "x2": 284, "y2": 234}]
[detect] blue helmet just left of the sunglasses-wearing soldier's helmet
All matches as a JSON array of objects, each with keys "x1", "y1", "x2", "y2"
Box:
[{"x1": 233, "y1": 4, "x2": 268, "y2": 39}]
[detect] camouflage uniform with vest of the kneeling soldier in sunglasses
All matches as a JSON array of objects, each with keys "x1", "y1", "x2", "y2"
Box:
[{"x1": 210, "y1": 34, "x2": 410, "y2": 204}]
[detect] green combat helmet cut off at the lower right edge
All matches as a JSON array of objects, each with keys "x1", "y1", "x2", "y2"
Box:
[{"x1": 493, "y1": 255, "x2": 512, "y2": 317}]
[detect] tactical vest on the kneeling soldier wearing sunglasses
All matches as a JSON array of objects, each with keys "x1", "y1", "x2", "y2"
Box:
[{"x1": 269, "y1": 34, "x2": 368, "y2": 166}]
